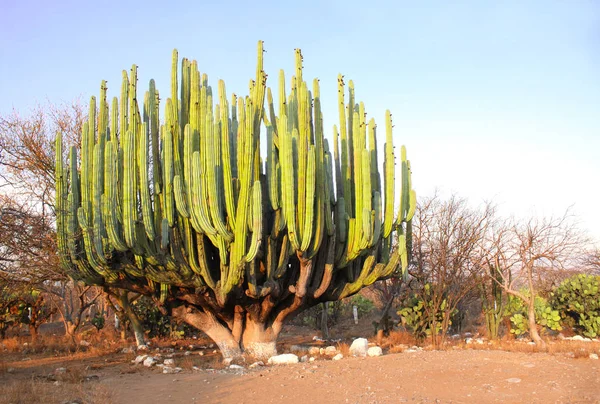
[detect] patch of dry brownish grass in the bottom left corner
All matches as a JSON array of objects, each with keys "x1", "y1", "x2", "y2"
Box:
[{"x1": 0, "y1": 380, "x2": 113, "y2": 404}]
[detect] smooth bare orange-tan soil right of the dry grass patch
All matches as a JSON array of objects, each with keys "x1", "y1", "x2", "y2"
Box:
[{"x1": 102, "y1": 350, "x2": 600, "y2": 404}]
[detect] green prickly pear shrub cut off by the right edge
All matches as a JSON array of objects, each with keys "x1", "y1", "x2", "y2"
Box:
[{"x1": 551, "y1": 274, "x2": 600, "y2": 338}]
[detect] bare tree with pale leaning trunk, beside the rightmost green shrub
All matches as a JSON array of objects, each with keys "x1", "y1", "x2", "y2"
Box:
[{"x1": 491, "y1": 211, "x2": 587, "y2": 348}]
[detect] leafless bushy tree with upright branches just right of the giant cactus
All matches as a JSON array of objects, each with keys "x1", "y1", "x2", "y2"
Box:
[{"x1": 409, "y1": 195, "x2": 495, "y2": 347}]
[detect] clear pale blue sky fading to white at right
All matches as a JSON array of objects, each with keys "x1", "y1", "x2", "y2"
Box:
[{"x1": 0, "y1": 0, "x2": 600, "y2": 240}]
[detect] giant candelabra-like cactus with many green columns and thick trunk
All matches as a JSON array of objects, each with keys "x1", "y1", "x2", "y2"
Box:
[{"x1": 56, "y1": 42, "x2": 415, "y2": 356}]
